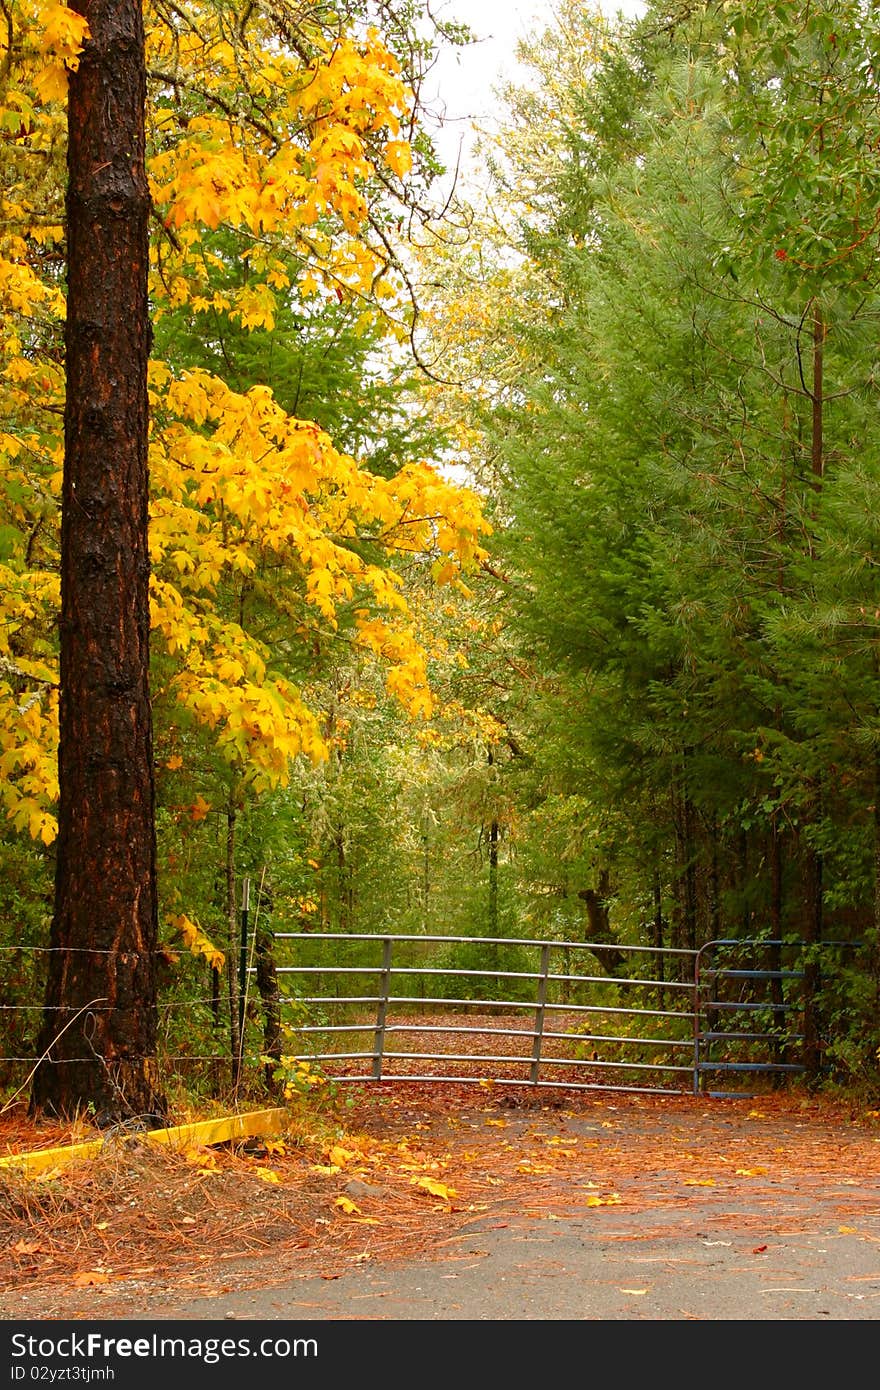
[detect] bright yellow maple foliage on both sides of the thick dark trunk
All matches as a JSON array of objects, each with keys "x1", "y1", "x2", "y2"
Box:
[{"x1": 0, "y1": 0, "x2": 489, "y2": 845}]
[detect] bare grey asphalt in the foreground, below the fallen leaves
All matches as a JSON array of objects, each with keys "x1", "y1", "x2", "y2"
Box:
[{"x1": 114, "y1": 1204, "x2": 880, "y2": 1322}]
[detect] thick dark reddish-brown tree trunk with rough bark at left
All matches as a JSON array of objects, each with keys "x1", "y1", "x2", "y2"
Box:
[{"x1": 32, "y1": 0, "x2": 165, "y2": 1118}]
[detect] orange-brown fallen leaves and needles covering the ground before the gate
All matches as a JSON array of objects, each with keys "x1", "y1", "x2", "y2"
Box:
[{"x1": 0, "y1": 1083, "x2": 880, "y2": 1316}]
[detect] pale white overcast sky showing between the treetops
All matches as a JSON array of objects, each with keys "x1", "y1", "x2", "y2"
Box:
[{"x1": 425, "y1": 0, "x2": 644, "y2": 186}]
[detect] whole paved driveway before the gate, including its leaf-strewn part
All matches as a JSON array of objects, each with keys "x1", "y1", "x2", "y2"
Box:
[{"x1": 0, "y1": 1099, "x2": 880, "y2": 1325}]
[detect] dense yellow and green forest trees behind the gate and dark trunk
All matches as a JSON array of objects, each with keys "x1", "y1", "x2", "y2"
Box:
[{"x1": 0, "y1": 0, "x2": 880, "y2": 1106}]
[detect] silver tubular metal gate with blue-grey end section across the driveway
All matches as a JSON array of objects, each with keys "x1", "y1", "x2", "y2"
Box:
[{"x1": 265, "y1": 933, "x2": 834, "y2": 1095}]
